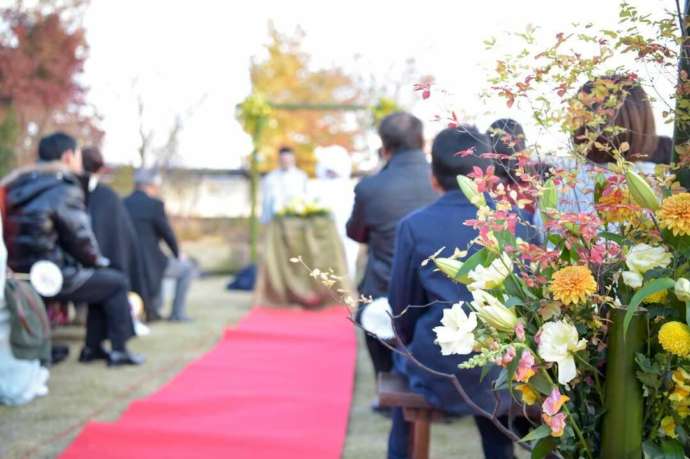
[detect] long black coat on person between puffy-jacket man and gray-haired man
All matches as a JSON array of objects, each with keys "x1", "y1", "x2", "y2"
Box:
[{"x1": 86, "y1": 183, "x2": 151, "y2": 305}]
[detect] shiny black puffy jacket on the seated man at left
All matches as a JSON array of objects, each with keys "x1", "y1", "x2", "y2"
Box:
[{"x1": 3, "y1": 163, "x2": 104, "y2": 293}]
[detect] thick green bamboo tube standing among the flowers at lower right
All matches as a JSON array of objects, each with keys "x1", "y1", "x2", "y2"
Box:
[{"x1": 600, "y1": 309, "x2": 647, "y2": 459}]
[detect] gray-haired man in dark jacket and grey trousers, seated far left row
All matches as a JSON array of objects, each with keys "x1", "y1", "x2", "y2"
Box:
[{"x1": 125, "y1": 169, "x2": 194, "y2": 322}]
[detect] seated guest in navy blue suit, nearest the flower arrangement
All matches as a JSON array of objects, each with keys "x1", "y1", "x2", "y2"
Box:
[{"x1": 388, "y1": 126, "x2": 513, "y2": 459}]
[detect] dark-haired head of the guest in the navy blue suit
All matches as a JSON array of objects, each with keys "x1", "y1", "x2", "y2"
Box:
[{"x1": 431, "y1": 125, "x2": 491, "y2": 191}]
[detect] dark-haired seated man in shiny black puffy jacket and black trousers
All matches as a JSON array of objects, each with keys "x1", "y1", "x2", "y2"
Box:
[{"x1": 3, "y1": 133, "x2": 143, "y2": 366}]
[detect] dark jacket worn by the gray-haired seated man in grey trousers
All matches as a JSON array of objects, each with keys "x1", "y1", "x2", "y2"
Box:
[{"x1": 124, "y1": 190, "x2": 179, "y2": 298}]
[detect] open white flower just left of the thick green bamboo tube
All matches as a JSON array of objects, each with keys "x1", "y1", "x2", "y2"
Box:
[{"x1": 538, "y1": 320, "x2": 587, "y2": 384}]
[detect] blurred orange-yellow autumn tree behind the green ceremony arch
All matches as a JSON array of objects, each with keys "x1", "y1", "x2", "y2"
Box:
[{"x1": 250, "y1": 24, "x2": 361, "y2": 177}]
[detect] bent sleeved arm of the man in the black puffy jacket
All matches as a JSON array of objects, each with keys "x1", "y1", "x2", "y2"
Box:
[{"x1": 53, "y1": 186, "x2": 108, "y2": 267}]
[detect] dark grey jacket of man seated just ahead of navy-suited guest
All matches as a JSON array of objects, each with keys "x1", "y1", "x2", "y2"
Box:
[{"x1": 347, "y1": 150, "x2": 438, "y2": 298}]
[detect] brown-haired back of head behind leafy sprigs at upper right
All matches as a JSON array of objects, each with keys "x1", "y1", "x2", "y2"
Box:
[{"x1": 571, "y1": 75, "x2": 657, "y2": 164}]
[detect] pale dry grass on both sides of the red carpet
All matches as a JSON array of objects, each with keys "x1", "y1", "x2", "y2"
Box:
[{"x1": 0, "y1": 278, "x2": 520, "y2": 459}]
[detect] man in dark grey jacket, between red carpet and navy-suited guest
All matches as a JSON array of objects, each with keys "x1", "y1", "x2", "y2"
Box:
[{"x1": 347, "y1": 113, "x2": 438, "y2": 386}]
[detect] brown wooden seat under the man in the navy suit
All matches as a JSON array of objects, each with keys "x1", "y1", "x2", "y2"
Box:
[{"x1": 378, "y1": 373, "x2": 445, "y2": 459}]
